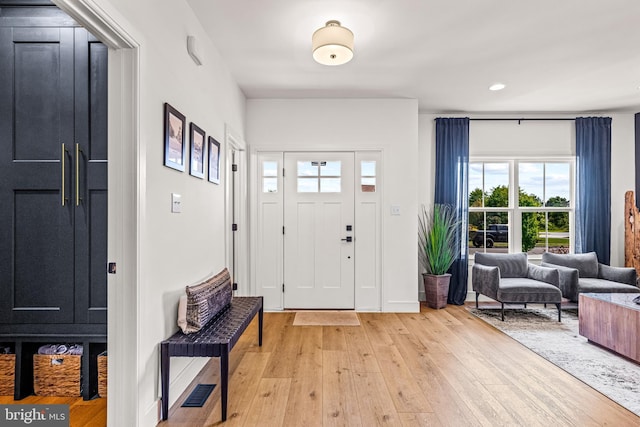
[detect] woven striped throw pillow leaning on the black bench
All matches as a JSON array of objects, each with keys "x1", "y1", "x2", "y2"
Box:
[{"x1": 178, "y1": 268, "x2": 233, "y2": 334}]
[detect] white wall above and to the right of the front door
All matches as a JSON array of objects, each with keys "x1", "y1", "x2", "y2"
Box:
[{"x1": 246, "y1": 99, "x2": 419, "y2": 312}]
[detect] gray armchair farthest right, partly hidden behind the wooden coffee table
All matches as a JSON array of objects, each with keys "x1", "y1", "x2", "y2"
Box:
[{"x1": 541, "y1": 252, "x2": 640, "y2": 302}]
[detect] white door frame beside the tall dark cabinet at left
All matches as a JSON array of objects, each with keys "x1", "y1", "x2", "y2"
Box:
[{"x1": 52, "y1": 0, "x2": 141, "y2": 426}]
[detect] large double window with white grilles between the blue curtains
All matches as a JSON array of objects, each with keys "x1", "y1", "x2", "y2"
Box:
[{"x1": 469, "y1": 159, "x2": 574, "y2": 256}]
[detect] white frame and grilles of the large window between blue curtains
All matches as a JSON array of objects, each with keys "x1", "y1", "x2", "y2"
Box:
[{"x1": 467, "y1": 156, "x2": 576, "y2": 260}]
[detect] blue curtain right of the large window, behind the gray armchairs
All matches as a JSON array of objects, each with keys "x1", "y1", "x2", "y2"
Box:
[{"x1": 576, "y1": 117, "x2": 611, "y2": 264}]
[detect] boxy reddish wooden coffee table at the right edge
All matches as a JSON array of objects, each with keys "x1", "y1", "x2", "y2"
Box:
[{"x1": 578, "y1": 293, "x2": 640, "y2": 363}]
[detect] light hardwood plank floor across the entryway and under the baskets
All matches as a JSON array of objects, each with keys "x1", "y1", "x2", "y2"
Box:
[{"x1": 0, "y1": 305, "x2": 640, "y2": 427}]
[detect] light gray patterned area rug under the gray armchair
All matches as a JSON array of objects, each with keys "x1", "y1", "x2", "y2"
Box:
[{"x1": 469, "y1": 308, "x2": 640, "y2": 416}]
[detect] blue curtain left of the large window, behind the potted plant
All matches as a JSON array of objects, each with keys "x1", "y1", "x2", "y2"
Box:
[{"x1": 434, "y1": 117, "x2": 469, "y2": 305}]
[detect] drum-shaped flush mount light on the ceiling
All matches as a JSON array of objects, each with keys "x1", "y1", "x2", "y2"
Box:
[{"x1": 311, "y1": 20, "x2": 353, "y2": 65}]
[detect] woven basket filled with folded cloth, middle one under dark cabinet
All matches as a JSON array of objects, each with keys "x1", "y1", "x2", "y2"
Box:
[{"x1": 33, "y1": 354, "x2": 82, "y2": 397}]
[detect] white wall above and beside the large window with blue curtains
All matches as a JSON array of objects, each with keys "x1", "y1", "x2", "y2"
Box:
[{"x1": 419, "y1": 112, "x2": 635, "y2": 300}]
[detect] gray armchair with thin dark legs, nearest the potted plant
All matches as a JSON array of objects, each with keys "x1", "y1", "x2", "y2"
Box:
[{"x1": 471, "y1": 252, "x2": 562, "y2": 322}]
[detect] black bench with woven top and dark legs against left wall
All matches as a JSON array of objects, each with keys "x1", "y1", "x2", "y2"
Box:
[{"x1": 160, "y1": 297, "x2": 264, "y2": 421}]
